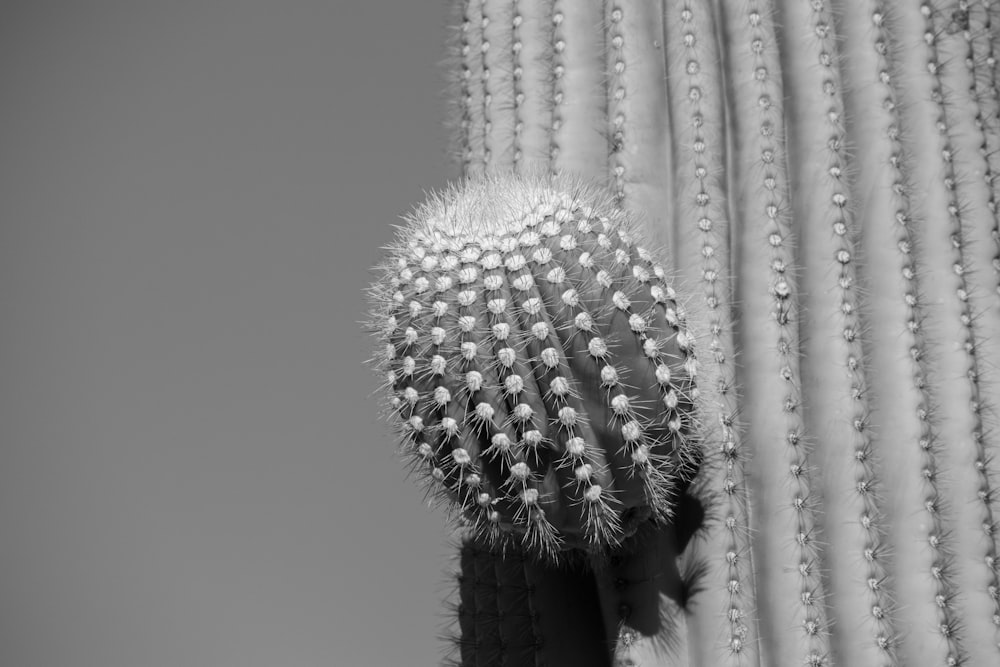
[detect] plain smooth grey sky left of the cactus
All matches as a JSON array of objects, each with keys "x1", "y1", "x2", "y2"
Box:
[{"x1": 0, "y1": 0, "x2": 455, "y2": 667}]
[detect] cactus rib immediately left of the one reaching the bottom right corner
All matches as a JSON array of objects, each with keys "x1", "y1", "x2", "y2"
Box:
[{"x1": 843, "y1": 1, "x2": 952, "y2": 664}]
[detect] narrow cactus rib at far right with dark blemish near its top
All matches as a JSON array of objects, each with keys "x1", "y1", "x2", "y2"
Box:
[{"x1": 920, "y1": 3, "x2": 1000, "y2": 660}]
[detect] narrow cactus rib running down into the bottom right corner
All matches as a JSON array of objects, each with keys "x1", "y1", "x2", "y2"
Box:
[{"x1": 895, "y1": 4, "x2": 993, "y2": 662}]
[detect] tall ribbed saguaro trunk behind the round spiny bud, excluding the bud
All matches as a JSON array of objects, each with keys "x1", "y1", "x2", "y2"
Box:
[{"x1": 370, "y1": 0, "x2": 1000, "y2": 666}]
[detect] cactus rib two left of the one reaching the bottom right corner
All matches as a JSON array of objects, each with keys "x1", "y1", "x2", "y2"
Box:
[{"x1": 779, "y1": 0, "x2": 896, "y2": 665}]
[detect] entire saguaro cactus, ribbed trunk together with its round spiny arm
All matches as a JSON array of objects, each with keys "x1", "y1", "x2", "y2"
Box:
[{"x1": 372, "y1": 0, "x2": 1000, "y2": 667}]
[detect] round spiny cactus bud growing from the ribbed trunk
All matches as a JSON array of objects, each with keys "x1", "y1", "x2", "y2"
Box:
[{"x1": 371, "y1": 175, "x2": 697, "y2": 557}]
